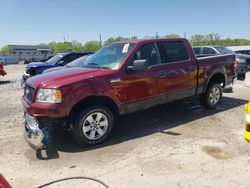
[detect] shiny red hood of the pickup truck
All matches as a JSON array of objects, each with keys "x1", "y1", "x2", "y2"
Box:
[{"x1": 27, "y1": 67, "x2": 113, "y2": 88}]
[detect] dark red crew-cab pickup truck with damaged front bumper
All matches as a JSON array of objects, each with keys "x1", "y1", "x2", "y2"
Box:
[{"x1": 22, "y1": 38, "x2": 236, "y2": 148}]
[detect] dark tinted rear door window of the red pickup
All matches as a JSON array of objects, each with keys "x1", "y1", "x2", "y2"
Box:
[{"x1": 158, "y1": 41, "x2": 189, "y2": 63}]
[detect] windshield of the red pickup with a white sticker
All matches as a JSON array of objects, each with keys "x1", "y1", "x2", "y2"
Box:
[{"x1": 84, "y1": 43, "x2": 134, "y2": 69}]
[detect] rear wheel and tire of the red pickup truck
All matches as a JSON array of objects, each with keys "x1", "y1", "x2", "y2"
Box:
[{"x1": 200, "y1": 83, "x2": 222, "y2": 109}]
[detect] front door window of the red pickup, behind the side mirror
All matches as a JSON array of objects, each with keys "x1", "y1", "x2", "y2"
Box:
[{"x1": 128, "y1": 43, "x2": 160, "y2": 66}]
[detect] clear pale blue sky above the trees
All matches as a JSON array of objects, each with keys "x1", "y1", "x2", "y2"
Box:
[{"x1": 0, "y1": 0, "x2": 250, "y2": 46}]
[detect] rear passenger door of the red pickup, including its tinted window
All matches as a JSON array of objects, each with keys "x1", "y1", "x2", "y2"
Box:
[{"x1": 158, "y1": 41, "x2": 197, "y2": 101}]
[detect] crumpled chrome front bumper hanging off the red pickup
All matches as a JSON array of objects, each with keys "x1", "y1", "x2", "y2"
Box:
[{"x1": 24, "y1": 113, "x2": 45, "y2": 149}]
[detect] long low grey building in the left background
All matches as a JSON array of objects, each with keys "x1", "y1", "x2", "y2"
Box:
[{"x1": 1, "y1": 45, "x2": 55, "y2": 64}]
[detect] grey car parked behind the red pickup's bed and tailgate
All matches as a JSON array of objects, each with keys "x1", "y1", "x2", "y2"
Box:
[{"x1": 193, "y1": 46, "x2": 250, "y2": 77}]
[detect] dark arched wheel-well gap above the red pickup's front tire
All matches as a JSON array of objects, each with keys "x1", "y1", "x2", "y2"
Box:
[{"x1": 69, "y1": 96, "x2": 119, "y2": 119}]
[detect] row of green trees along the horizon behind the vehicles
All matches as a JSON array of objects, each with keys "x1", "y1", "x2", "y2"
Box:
[{"x1": 0, "y1": 33, "x2": 250, "y2": 55}]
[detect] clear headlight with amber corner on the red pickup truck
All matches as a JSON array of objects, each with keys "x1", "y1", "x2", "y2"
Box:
[{"x1": 36, "y1": 89, "x2": 62, "y2": 103}]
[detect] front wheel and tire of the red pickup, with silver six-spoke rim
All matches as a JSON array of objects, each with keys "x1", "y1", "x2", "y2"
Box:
[{"x1": 72, "y1": 106, "x2": 114, "y2": 145}]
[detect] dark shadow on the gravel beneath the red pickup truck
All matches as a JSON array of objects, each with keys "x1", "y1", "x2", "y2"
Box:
[{"x1": 55, "y1": 97, "x2": 248, "y2": 153}]
